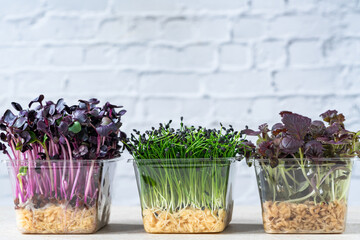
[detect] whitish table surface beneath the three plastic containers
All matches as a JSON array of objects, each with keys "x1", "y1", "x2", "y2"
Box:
[{"x1": 0, "y1": 206, "x2": 360, "y2": 240}]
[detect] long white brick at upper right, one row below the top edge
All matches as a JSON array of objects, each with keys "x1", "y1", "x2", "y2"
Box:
[{"x1": 268, "y1": 15, "x2": 336, "y2": 38}]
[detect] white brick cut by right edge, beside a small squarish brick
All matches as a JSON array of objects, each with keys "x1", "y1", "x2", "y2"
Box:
[{"x1": 325, "y1": 39, "x2": 360, "y2": 64}]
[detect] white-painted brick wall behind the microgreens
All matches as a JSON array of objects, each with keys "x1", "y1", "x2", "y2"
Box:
[{"x1": 0, "y1": 0, "x2": 360, "y2": 205}]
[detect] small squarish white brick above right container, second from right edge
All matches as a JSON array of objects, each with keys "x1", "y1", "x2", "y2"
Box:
[{"x1": 289, "y1": 41, "x2": 323, "y2": 66}]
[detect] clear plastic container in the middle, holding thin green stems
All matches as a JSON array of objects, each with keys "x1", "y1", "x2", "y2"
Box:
[{"x1": 133, "y1": 158, "x2": 236, "y2": 233}]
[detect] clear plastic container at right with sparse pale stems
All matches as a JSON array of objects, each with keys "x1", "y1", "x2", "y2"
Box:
[{"x1": 254, "y1": 158, "x2": 354, "y2": 233}]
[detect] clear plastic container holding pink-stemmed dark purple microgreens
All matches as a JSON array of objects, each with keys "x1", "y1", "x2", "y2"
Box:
[{"x1": 7, "y1": 159, "x2": 119, "y2": 234}]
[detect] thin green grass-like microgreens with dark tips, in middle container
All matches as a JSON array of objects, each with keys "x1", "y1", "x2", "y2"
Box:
[{"x1": 124, "y1": 118, "x2": 251, "y2": 211}]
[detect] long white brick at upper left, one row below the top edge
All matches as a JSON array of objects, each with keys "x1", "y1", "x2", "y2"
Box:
[{"x1": 19, "y1": 16, "x2": 96, "y2": 41}]
